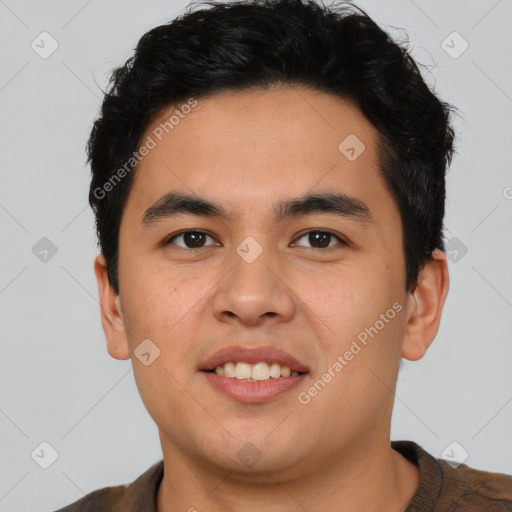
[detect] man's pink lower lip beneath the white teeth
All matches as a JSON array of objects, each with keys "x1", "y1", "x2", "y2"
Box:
[{"x1": 201, "y1": 372, "x2": 307, "y2": 403}]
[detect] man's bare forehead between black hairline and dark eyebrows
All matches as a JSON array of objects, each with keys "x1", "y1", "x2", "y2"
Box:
[{"x1": 126, "y1": 87, "x2": 392, "y2": 224}]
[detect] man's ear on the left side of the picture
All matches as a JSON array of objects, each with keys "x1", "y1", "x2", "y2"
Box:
[{"x1": 94, "y1": 254, "x2": 130, "y2": 359}]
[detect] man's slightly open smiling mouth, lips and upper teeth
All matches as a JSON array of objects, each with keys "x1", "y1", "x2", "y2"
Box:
[{"x1": 199, "y1": 346, "x2": 309, "y2": 403}]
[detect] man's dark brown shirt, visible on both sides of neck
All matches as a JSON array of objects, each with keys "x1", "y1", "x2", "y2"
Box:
[{"x1": 52, "y1": 441, "x2": 512, "y2": 512}]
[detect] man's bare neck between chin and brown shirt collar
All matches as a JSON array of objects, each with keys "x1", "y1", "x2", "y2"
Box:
[{"x1": 157, "y1": 437, "x2": 419, "y2": 512}]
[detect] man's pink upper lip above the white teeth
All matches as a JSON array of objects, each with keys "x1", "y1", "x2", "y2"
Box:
[{"x1": 199, "y1": 345, "x2": 309, "y2": 373}]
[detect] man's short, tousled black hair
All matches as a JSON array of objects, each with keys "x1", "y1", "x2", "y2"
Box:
[{"x1": 87, "y1": 0, "x2": 456, "y2": 294}]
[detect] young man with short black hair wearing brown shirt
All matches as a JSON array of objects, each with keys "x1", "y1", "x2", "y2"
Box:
[{"x1": 54, "y1": 0, "x2": 512, "y2": 512}]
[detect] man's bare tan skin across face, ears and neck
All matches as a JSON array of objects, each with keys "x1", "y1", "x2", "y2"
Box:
[{"x1": 95, "y1": 87, "x2": 449, "y2": 512}]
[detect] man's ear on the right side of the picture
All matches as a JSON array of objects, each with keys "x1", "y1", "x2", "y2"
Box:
[{"x1": 402, "y1": 249, "x2": 449, "y2": 361}]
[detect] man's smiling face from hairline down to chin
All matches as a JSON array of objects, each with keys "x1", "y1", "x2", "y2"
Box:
[{"x1": 97, "y1": 88, "x2": 448, "y2": 477}]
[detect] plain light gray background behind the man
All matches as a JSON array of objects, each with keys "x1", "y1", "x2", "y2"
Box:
[{"x1": 0, "y1": 0, "x2": 512, "y2": 511}]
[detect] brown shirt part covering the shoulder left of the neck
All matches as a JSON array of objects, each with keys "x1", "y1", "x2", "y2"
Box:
[{"x1": 50, "y1": 460, "x2": 163, "y2": 512}]
